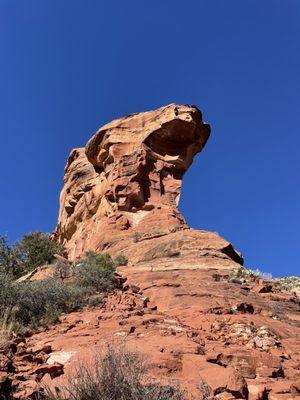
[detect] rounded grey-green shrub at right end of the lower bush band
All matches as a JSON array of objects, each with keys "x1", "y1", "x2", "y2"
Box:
[{"x1": 74, "y1": 251, "x2": 116, "y2": 292}]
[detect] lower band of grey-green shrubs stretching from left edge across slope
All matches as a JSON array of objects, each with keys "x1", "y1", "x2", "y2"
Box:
[{"x1": 0, "y1": 248, "x2": 122, "y2": 331}]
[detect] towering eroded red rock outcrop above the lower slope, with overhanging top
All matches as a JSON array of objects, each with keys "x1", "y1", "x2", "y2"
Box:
[{"x1": 55, "y1": 104, "x2": 241, "y2": 268}]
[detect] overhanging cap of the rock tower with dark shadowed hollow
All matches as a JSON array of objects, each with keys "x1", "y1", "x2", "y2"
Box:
[{"x1": 85, "y1": 104, "x2": 210, "y2": 171}]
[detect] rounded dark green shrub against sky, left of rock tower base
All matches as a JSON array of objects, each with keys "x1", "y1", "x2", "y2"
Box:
[{"x1": 15, "y1": 231, "x2": 64, "y2": 272}]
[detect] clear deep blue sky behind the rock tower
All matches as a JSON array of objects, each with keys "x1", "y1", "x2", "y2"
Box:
[{"x1": 0, "y1": 0, "x2": 300, "y2": 276}]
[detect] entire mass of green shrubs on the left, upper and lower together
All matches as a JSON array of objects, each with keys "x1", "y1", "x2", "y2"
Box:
[{"x1": 0, "y1": 227, "x2": 127, "y2": 336}]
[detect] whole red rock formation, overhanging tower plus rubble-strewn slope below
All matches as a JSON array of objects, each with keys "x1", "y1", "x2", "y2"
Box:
[{"x1": 0, "y1": 104, "x2": 300, "y2": 400}]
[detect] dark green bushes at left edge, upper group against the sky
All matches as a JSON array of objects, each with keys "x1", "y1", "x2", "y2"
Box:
[{"x1": 0, "y1": 231, "x2": 64, "y2": 278}]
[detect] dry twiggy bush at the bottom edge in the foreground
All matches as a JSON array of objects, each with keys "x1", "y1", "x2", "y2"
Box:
[{"x1": 43, "y1": 346, "x2": 184, "y2": 400}]
